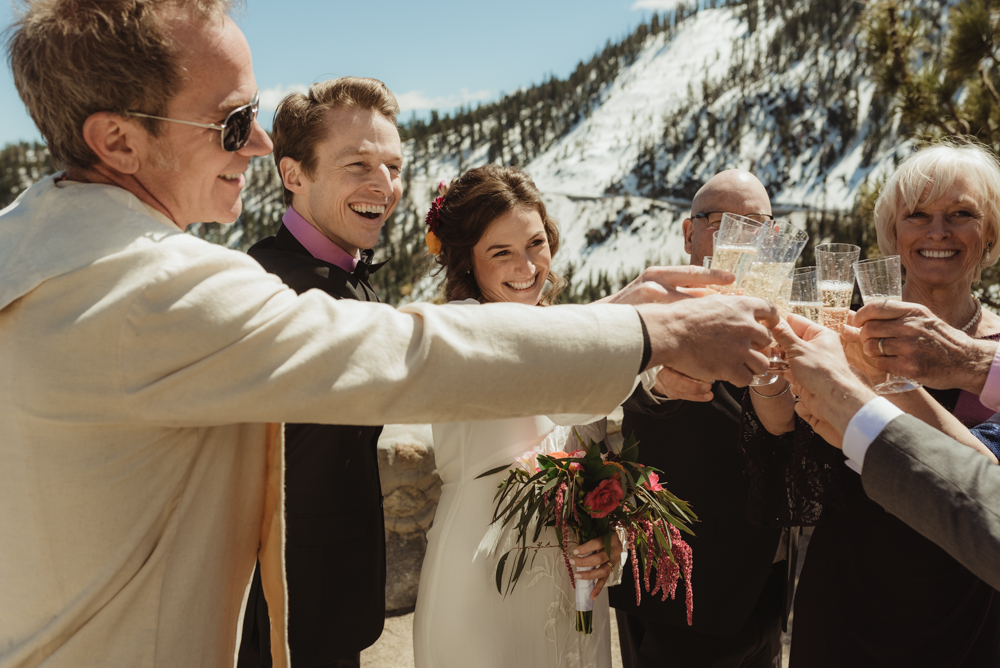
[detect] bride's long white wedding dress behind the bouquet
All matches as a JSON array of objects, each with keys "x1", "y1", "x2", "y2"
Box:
[{"x1": 413, "y1": 416, "x2": 611, "y2": 668}]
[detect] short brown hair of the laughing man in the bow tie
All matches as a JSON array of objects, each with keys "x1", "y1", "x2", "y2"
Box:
[{"x1": 271, "y1": 77, "x2": 399, "y2": 206}]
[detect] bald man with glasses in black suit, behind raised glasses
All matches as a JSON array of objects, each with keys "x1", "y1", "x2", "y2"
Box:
[{"x1": 610, "y1": 169, "x2": 797, "y2": 668}]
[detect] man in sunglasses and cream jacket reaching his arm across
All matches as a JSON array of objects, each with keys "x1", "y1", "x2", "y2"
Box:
[{"x1": 0, "y1": 0, "x2": 777, "y2": 668}]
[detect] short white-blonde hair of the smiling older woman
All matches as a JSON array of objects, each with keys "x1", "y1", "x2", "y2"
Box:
[{"x1": 875, "y1": 138, "x2": 1000, "y2": 282}]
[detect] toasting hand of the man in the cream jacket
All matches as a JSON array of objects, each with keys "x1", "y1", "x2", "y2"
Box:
[{"x1": 635, "y1": 296, "x2": 779, "y2": 387}]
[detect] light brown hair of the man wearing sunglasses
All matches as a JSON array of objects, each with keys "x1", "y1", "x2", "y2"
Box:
[{"x1": 6, "y1": 0, "x2": 231, "y2": 168}]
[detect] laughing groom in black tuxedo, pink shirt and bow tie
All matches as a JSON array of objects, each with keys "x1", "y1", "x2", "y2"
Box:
[{"x1": 237, "y1": 77, "x2": 403, "y2": 668}]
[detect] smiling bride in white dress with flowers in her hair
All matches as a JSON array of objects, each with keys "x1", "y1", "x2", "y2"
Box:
[{"x1": 413, "y1": 165, "x2": 653, "y2": 668}]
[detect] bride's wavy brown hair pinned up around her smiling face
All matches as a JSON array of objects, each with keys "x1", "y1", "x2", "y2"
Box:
[{"x1": 436, "y1": 165, "x2": 566, "y2": 306}]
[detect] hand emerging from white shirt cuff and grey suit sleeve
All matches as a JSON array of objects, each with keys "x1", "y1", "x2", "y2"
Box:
[{"x1": 771, "y1": 314, "x2": 875, "y2": 448}]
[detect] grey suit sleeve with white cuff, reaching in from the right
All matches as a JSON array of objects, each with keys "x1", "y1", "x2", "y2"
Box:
[{"x1": 861, "y1": 415, "x2": 1000, "y2": 589}]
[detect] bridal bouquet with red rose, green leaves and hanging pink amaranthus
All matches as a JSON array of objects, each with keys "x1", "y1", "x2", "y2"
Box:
[{"x1": 479, "y1": 431, "x2": 697, "y2": 633}]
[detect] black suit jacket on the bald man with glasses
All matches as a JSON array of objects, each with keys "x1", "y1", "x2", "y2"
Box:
[{"x1": 609, "y1": 382, "x2": 781, "y2": 636}]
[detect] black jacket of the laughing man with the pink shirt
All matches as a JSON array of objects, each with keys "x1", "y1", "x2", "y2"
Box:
[{"x1": 239, "y1": 225, "x2": 385, "y2": 668}]
